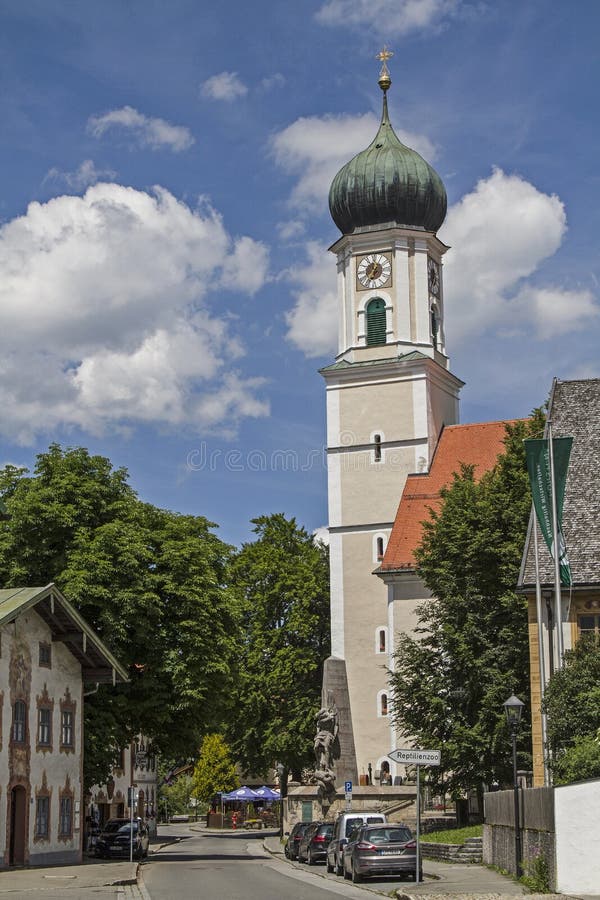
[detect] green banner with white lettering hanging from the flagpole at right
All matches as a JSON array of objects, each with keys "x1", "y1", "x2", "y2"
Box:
[{"x1": 524, "y1": 437, "x2": 573, "y2": 587}]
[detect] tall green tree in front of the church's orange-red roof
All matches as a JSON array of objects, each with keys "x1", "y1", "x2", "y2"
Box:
[{"x1": 390, "y1": 411, "x2": 543, "y2": 792}]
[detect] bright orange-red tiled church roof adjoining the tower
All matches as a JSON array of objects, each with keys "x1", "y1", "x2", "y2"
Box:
[{"x1": 377, "y1": 422, "x2": 512, "y2": 575}]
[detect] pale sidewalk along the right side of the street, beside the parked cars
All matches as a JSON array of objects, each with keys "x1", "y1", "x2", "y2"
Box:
[{"x1": 263, "y1": 836, "x2": 579, "y2": 900}]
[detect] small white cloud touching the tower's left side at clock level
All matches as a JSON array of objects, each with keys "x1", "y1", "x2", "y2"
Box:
[{"x1": 286, "y1": 241, "x2": 338, "y2": 358}]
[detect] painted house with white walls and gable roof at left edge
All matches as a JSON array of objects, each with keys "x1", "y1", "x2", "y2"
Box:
[{"x1": 0, "y1": 584, "x2": 128, "y2": 867}]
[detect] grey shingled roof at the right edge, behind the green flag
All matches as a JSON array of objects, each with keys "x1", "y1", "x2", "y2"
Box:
[{"x1": 518, "y1": 378, "x2": 600, "y2": 590}]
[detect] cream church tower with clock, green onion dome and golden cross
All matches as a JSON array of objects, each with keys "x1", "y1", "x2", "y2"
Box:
[{"x1": 321, "y1": 56, "x2": 462, "y2": 789}]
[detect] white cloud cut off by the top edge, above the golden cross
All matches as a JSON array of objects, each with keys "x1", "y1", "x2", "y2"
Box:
[{"x1": 316, "y1": 0, "x2": 462, "y2": 37}]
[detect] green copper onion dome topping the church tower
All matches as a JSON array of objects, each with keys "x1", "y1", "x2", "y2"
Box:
[{"x1": 329, "y1": 92, "x2": 446, "y2": 234}]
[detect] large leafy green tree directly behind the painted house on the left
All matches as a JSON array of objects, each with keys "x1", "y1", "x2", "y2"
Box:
[{"x1": 0, "y1": 444, "x2": 237, "y2": 785}]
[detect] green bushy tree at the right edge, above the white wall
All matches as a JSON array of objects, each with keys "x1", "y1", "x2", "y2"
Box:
[{"x1": 544, "y1": 636, "x2": 600, "y2": 784}]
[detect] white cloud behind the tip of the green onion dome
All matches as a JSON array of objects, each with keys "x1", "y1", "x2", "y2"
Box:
[{"x1": 273, "y1": 113, "x2": 435, "y2": 212}]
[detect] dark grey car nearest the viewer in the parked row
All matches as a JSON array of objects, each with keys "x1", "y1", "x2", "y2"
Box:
[{"x1": 343, "y1": 822, "x2": 423, "y2": 882}]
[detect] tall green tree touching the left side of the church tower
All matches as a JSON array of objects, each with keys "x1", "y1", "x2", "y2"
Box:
[{"x1": 229, "y1": 513, "x2": 329, "y2": 790}]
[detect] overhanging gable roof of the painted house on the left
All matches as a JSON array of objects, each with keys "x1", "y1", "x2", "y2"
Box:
[{"x1": 0, "y1": 584, "x2": 129, "y2": 684}]
